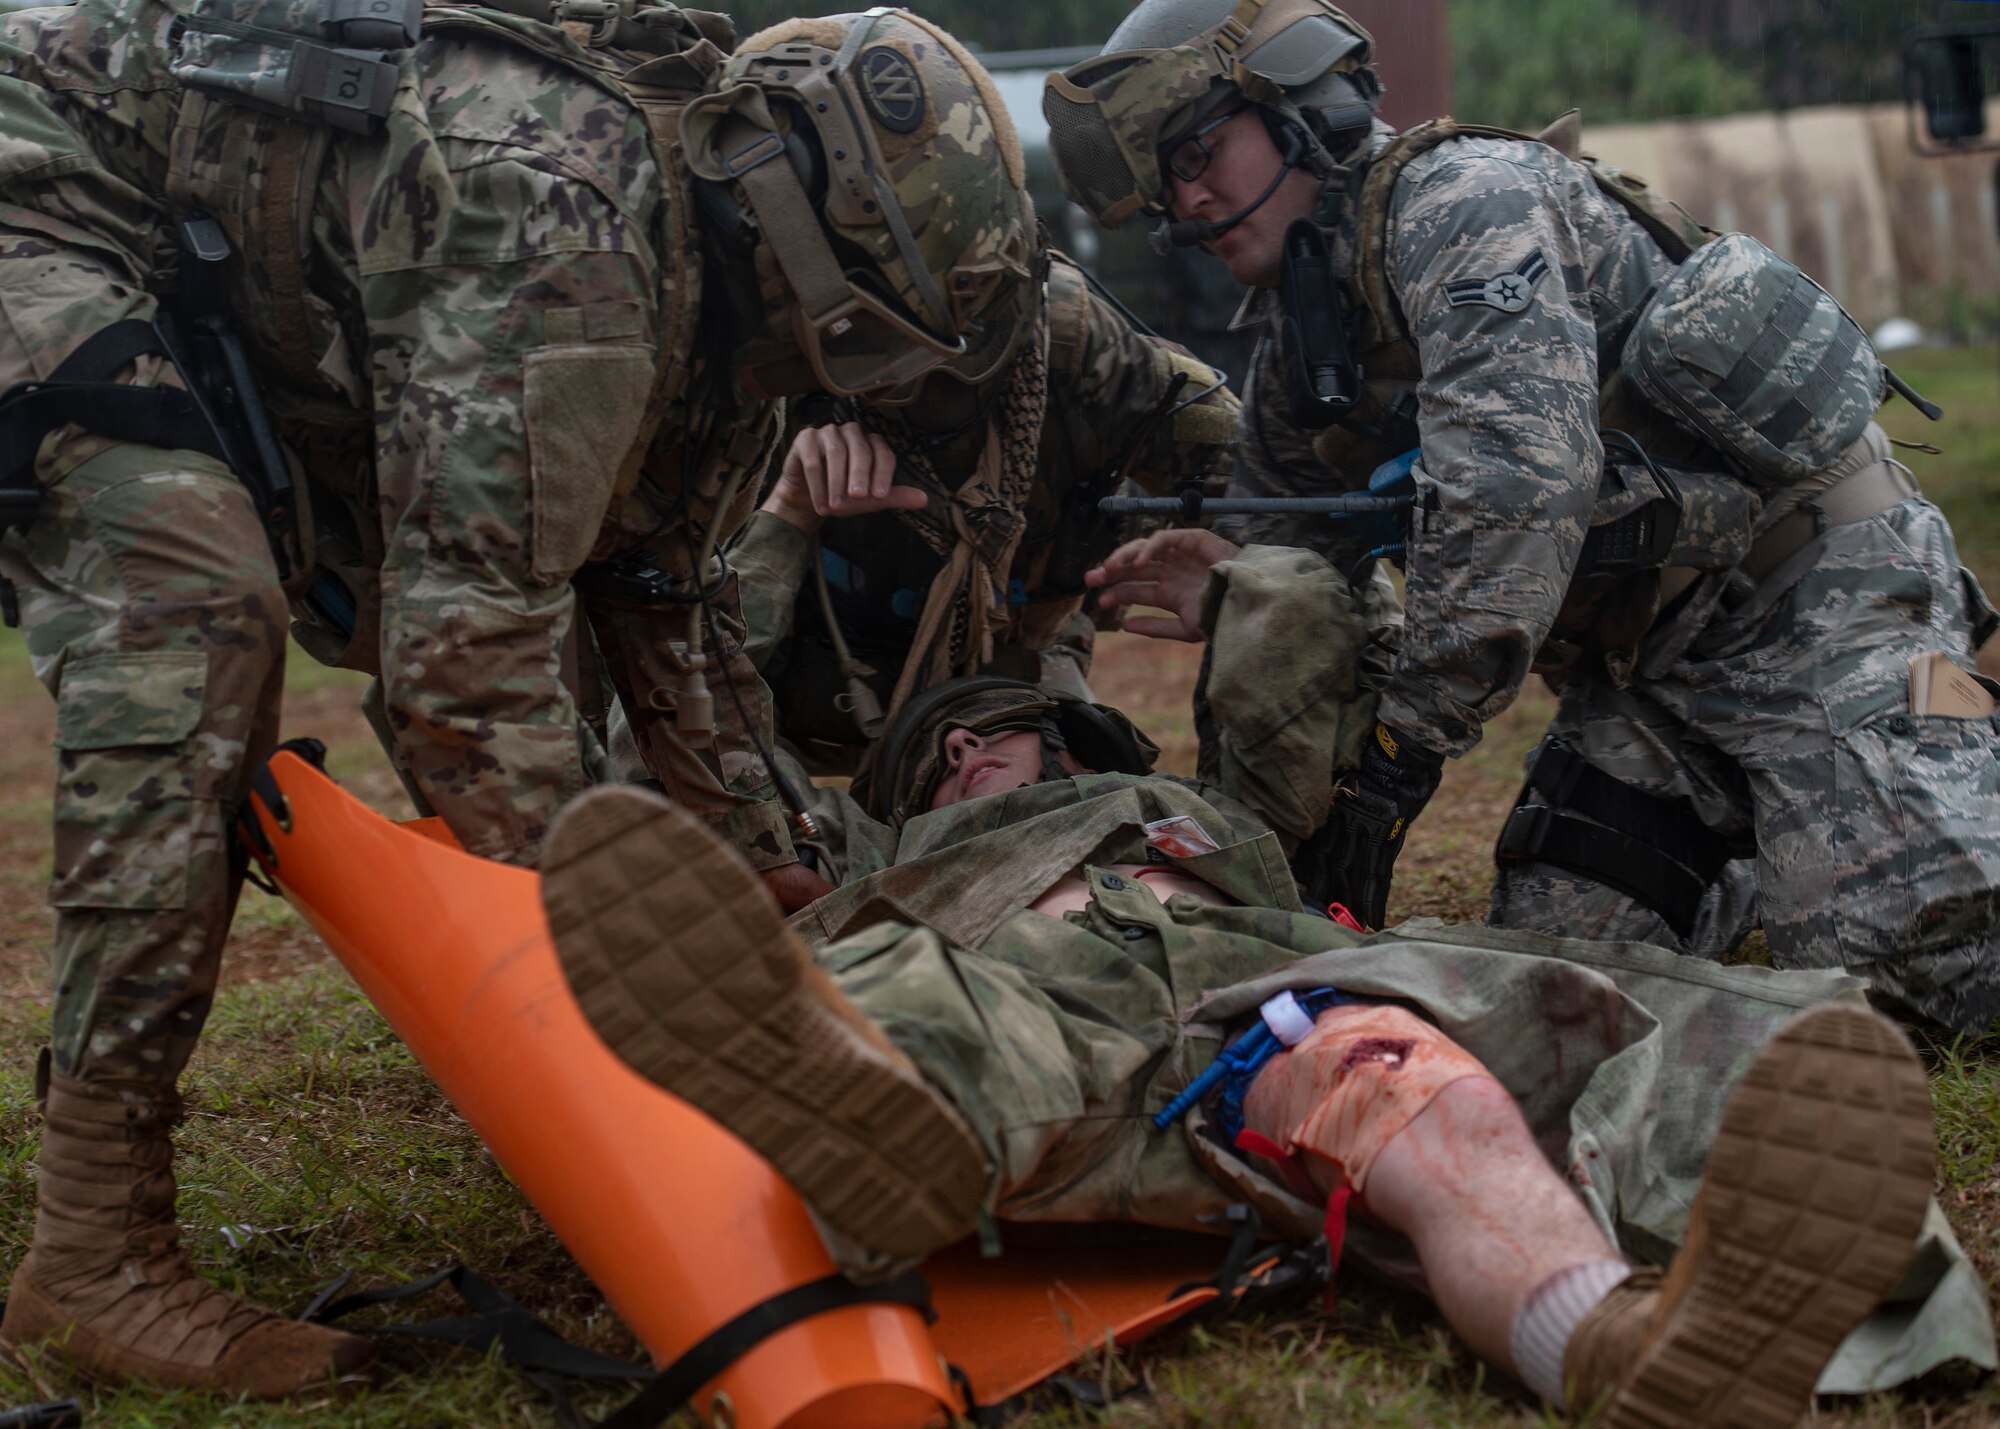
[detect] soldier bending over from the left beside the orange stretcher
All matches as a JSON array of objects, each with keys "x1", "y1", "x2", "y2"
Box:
[{"x1": 0, "y1": 0, "x2": 1034, "y2": 1395}]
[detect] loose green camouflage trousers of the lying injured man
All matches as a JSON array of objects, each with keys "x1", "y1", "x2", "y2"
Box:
[{"x1": 818, "y1": 884, "x2": 1994, "y2": 1393}]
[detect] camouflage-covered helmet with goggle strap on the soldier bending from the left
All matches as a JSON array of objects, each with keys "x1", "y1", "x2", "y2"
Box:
[{"x1": 680, "y1": 10, "x2": 1046, "y2": 400}]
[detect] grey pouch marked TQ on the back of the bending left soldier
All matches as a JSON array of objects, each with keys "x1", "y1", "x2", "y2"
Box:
[{"x1": 168, "y1": 0, "x2": 424, "y2": 134}]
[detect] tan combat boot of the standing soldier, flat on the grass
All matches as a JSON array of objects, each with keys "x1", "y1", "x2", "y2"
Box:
[{"x1": 0, "y1": 1077, "x2": 370, "y2": 1399}]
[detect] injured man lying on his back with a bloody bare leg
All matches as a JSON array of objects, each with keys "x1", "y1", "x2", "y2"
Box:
[{"x1": 544, "y1": 532, "x2": 1992, "y2": 1425}]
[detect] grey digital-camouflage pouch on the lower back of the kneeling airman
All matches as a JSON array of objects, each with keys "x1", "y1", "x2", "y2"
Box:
[{"x1": 1622, "y1": 234, "x2": 1888, "y2": 486}]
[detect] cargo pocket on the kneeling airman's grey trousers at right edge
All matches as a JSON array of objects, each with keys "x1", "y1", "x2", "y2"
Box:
[{"x1": 1832, "y1": 710, "x2": 2000, "y2": 959}]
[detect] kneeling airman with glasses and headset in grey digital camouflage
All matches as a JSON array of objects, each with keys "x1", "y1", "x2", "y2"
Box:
[{"x1": 1044, "y1": 0, "x2": 2000, "y2": 1031}]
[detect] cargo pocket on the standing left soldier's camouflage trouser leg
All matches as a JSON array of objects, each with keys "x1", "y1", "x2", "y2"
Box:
[{"x1": 48, "y1": 650, "x2": 208, "y2": 909}]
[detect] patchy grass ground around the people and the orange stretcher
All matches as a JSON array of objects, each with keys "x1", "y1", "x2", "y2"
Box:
[{"x1": 0, "y1": 350, "x2": 2000, "y2": 1429}]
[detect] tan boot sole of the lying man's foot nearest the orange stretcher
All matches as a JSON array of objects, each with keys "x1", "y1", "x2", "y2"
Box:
[{"x1": 542, "y1": 789, "x2": 986, "y2": 1259}]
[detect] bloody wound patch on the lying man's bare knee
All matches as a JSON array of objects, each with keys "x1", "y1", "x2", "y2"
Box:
[{"x1": 1244, "y1": 1003, "x2": 1492, "y2": 1195}]
